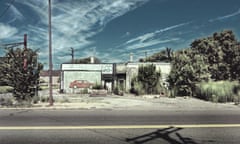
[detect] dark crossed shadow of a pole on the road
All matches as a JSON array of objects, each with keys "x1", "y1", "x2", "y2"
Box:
[{"x1": 125, "y1": 127, "x2": 197, "y2": 144}]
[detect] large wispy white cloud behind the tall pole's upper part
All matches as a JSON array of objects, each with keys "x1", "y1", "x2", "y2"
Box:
[{"x1": 18, "y1": 0, "x2": 149, "y2": 66}]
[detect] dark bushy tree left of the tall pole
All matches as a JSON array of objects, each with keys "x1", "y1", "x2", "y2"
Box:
[{"x1": 0, "y1": 48, "x2": 43, "y2": 102}]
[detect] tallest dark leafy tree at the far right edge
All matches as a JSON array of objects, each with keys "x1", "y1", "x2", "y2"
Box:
[{"x1": 191, "y1": 30, "x2": 239, "y2": 81}]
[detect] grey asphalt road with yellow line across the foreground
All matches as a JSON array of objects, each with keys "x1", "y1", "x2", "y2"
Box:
[{"x1": 0, "y1": 110, "x2": 240, "y2": 144}]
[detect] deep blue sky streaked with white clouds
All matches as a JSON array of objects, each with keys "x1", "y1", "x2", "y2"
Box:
[{"x1": 0, "y1": 0, "x2": 240, "y2": 69}]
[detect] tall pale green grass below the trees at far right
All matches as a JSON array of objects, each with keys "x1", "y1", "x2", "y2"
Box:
[{"x1": 196, "y1": 81, "x2": 239, "y2": 103}]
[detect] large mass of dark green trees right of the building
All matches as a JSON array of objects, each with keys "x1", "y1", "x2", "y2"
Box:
[{"x1": 168, "y1": 30, "x2": 240, "y2": 95}]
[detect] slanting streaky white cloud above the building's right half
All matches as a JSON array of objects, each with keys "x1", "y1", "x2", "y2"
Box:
[{"x1": 109, "y1": 22, "x2": 192, "y2": 62}]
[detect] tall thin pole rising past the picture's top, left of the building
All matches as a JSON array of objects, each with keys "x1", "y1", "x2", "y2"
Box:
[{"x1": 48, "y1": 0, "x2": 53, "y2": 106}]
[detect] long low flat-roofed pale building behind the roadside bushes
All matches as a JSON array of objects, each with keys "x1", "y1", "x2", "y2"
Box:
[{"x1": 60, "y1": 63, "x2": 171, "y2": 93}]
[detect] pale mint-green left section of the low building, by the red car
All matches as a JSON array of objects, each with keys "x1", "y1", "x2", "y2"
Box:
[{"x1": 60, "y1": 64, "x2": 113, "y2": 93}]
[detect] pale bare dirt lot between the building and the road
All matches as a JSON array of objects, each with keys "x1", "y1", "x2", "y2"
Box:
[{"x1": 29, "y1": 92, "x2": 239, "y2": 110}]
